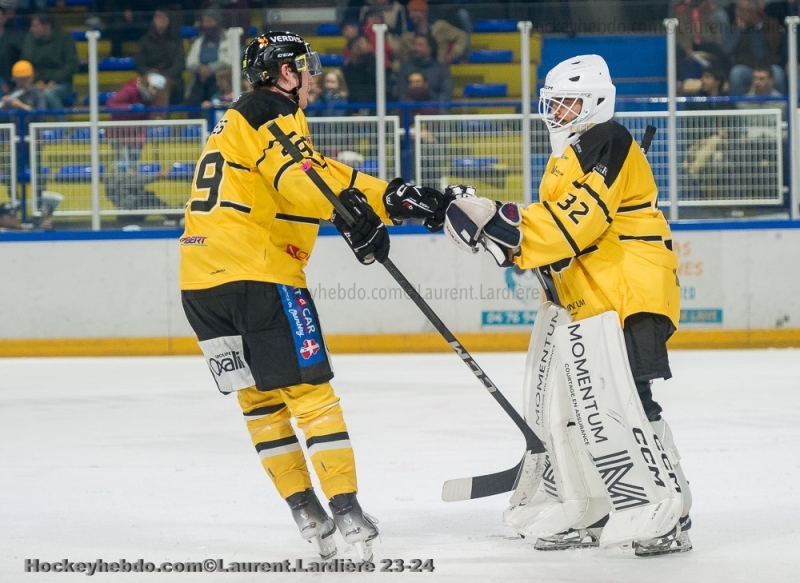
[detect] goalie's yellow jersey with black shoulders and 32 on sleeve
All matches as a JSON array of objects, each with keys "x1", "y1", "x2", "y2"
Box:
[{"x1": 515, "y1": 121, "x2": 680, "y2": 327}]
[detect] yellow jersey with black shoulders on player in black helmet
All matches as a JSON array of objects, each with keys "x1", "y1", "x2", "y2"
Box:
[{"x1": 180, "y1": 90, "x2": 390, "y2": 290}]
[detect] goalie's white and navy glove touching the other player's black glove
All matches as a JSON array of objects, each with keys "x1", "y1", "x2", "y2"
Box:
[{"x1": 444, "y1": 196, "x2": 522, "y2": 267}]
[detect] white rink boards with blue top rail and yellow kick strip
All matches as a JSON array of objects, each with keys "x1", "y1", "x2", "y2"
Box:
[{"x1": 0, "y1": 221, "x2": 800, "y2": 356}]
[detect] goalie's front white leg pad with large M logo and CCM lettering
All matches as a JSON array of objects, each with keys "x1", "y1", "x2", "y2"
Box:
[{"x1": 555, "y1": 312, "x2": 683, "y2": 547}]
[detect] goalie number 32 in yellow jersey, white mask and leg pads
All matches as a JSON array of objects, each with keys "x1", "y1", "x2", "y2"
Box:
[{"x1": 445, "y1": 55, "x2": 691, "y2": 556}]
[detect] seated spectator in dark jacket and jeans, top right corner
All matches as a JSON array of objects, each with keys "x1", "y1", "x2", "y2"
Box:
[{"x1": 723, "y1": 0, "x2": 786, "y2": 95}]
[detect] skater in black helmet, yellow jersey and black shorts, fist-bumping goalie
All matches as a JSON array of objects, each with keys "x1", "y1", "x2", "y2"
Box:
[{"x1": 180, "y1": 32, "x2": 456, "y2": 560}]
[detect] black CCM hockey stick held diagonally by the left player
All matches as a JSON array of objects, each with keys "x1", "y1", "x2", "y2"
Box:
[{"x1": 267, "y1": 121, "x2": 544, "y2": 492}]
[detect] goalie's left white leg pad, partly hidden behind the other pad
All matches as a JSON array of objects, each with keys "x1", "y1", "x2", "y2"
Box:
[{"x1": 503, "y1": 302, "x2": 609, "y2": 537}]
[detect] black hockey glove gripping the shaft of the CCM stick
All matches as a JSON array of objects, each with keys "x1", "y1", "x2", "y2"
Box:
[{"x1": 331, "y1": 188, "x2": 389, "y2": 265}]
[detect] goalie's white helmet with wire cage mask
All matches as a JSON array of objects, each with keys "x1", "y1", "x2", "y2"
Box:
[{"x1": 539, "y1": 55, "x2": 617, "y2": 156}]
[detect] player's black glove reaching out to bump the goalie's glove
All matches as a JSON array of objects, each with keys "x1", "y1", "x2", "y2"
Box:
[{"x1": 383, "y1": 178, "x2": 452, "y2": 233}]
